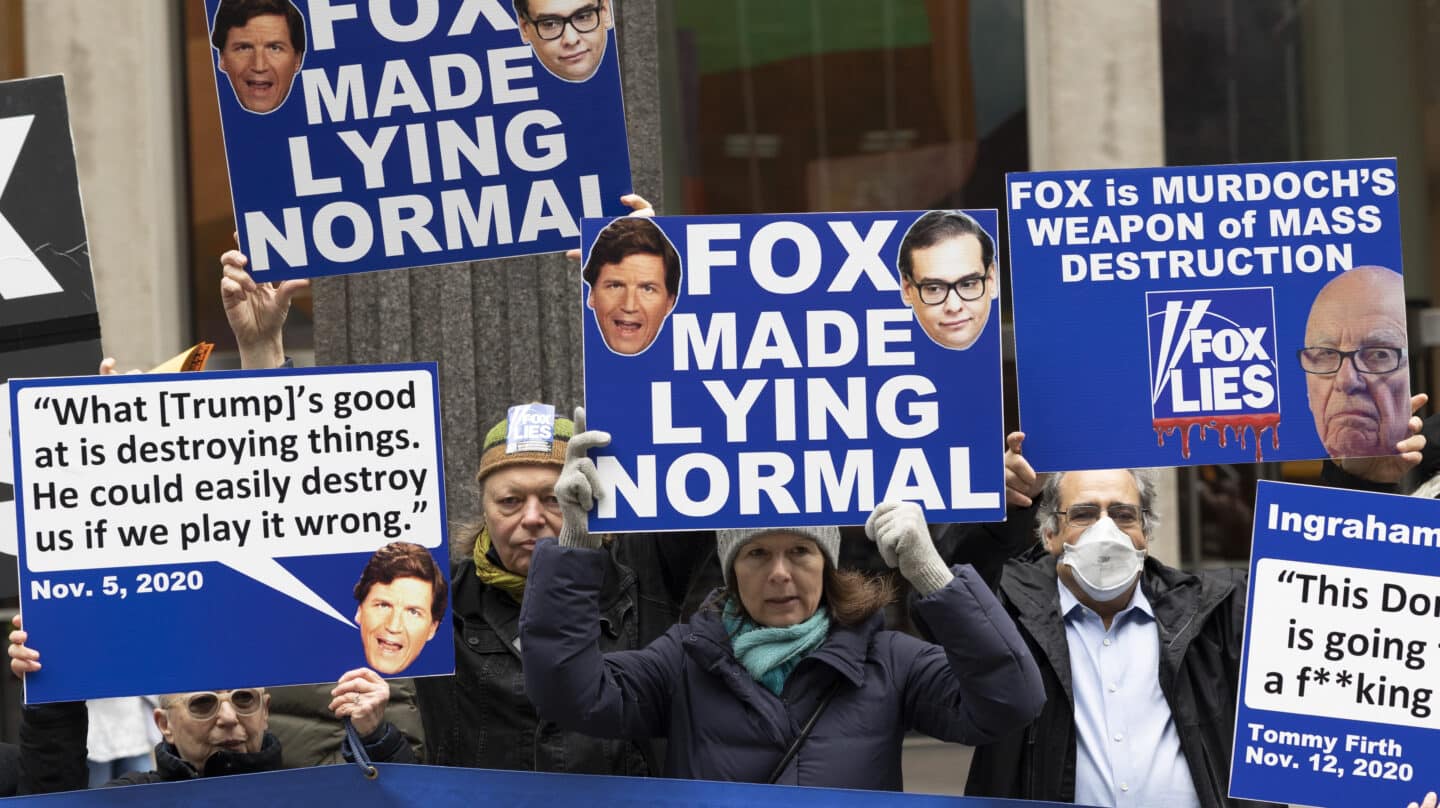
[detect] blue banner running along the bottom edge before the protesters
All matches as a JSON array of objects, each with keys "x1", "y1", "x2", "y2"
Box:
[{"x1": 4, "y1": 763, "x2": 1094, "y2": 808}]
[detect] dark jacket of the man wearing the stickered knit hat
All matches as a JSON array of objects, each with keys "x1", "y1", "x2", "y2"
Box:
[{"x1": 415, "y1": 531, "x2": 720, "y2": 776}]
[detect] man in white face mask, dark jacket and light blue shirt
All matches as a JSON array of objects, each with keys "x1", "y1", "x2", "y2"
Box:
[{"x1": 937, "y1": 434, "x2": 1284, "y2": 808}]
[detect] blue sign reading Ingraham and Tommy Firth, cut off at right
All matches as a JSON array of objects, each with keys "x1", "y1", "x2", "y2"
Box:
[{"x1": 1230, "y1": 481, "x2": 1440, "y2": 807}]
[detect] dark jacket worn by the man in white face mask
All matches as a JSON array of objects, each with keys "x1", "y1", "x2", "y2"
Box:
[{"x1": 940, "y1": 508, "x2": 1270, "y2": 808}]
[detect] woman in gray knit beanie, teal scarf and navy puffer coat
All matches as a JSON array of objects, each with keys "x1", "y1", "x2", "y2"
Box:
[{"x1": 520, "y1": 410, "x2": 1044, "y2": 791}]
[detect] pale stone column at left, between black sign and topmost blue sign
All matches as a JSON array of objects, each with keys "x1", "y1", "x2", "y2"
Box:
[{"x1": 24, "y1": 0, "x2": 190, "y2": 367}]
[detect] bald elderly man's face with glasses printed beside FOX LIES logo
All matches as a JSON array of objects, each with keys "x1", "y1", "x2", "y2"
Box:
[{"x1": 1299, "y1": 266, "x2": 1410, "y2": 458}]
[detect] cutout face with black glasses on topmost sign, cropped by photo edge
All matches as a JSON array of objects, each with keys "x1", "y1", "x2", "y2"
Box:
[{"x1": 516, "y1": 0, "x2": 615, "y2": 82}]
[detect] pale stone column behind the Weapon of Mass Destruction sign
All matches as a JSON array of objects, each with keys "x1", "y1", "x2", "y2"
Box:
[{"x1": 1025, "y1": 0, "x2": 1179, "y2": 565}]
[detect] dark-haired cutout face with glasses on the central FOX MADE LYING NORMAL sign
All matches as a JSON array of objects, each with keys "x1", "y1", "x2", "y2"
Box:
[{"x1": 897, "y1": 210, "x2": 999, "y2": 350}]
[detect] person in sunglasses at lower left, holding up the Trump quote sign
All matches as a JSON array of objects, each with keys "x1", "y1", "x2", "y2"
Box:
[{"x1": 9, "y1": 616, "x2": 416, "y2": 794}]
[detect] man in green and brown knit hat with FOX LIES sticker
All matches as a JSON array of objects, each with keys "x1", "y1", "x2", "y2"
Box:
[{"x1": 416, "y1": 403, "x2": 719, "y2": 775}]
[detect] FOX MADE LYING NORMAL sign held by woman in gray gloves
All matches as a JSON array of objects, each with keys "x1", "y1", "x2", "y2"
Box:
[{"x1": 580, "y1": 210, "x2": 1004, "y2": 530}]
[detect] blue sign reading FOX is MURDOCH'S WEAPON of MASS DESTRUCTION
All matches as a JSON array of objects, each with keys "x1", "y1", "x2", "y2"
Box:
[{"x1": 1007, "y1": 158, "x2": 1410, "y2": 471}]
